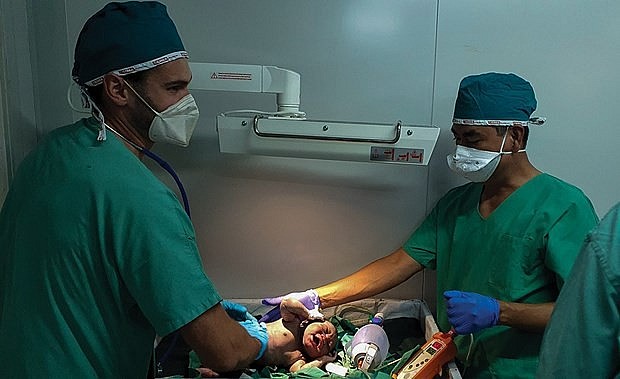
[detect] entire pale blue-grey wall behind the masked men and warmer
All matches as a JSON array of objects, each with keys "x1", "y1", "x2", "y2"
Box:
[{"x1": 0, "y1": 0, "x2": 620, "y2": 314}]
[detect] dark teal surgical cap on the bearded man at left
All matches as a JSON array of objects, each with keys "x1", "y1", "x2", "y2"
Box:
[{"x1": 72, "y1": 1, "x2": 188, "y2": 86}]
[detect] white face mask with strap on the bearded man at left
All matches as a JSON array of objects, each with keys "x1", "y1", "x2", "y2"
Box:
[{"x1": 125, "y1": 82, "x2": 200, "y2": 147}]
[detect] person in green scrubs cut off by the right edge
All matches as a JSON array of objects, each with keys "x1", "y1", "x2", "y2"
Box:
[{"x1": 537, "y1": 203, "x2": 620, "y2": 379}]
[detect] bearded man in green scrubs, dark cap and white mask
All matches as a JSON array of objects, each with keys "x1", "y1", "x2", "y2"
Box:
[{"x1": 0, "y1": 2, "x2": 268, "y2": 378}]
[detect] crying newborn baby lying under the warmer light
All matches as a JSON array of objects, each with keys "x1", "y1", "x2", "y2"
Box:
[{"x1": 198, "y1": 298, "x2": 338, "y2": 377}]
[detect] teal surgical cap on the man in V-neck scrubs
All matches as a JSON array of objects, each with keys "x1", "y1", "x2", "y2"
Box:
[{"x1": 452, "y1": 72, "x2": 536, "y2": 126}]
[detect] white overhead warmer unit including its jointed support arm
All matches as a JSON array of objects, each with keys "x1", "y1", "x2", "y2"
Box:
[{"x1": 190, "y1": 62, "x2": 440, "y2": 165}]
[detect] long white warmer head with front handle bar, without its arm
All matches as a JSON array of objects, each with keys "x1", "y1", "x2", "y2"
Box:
[{"x1": 217, "y1": 115, "x2": 439, "y2": 165}]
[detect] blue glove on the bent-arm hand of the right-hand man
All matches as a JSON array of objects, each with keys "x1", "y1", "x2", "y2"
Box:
[{"x1": 443, "y1": 291, "x2": 499, "y2": 334}]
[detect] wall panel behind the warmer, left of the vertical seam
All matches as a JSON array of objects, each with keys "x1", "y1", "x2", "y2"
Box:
[{"x1": 67, "y1": 0, "x2": 436, "y2": 298}]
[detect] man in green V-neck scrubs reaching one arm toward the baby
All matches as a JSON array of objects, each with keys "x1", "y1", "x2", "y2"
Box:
[{"x1": 265, "y1": 73, "x2": 598, "y2": 378}]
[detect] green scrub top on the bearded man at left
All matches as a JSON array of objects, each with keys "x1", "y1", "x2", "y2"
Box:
[{"x1": 0, "y1": 119, "x2": 221, "y2": 378}]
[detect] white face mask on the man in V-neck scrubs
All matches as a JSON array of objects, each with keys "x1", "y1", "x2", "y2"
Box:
[{"x1": 447, "y1": 131, "x2": 525, "y2": 183}]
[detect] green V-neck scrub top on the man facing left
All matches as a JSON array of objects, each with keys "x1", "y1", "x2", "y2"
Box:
[{"x1": 404, "y1": 174, "x2": 598, "y2": 378}]
